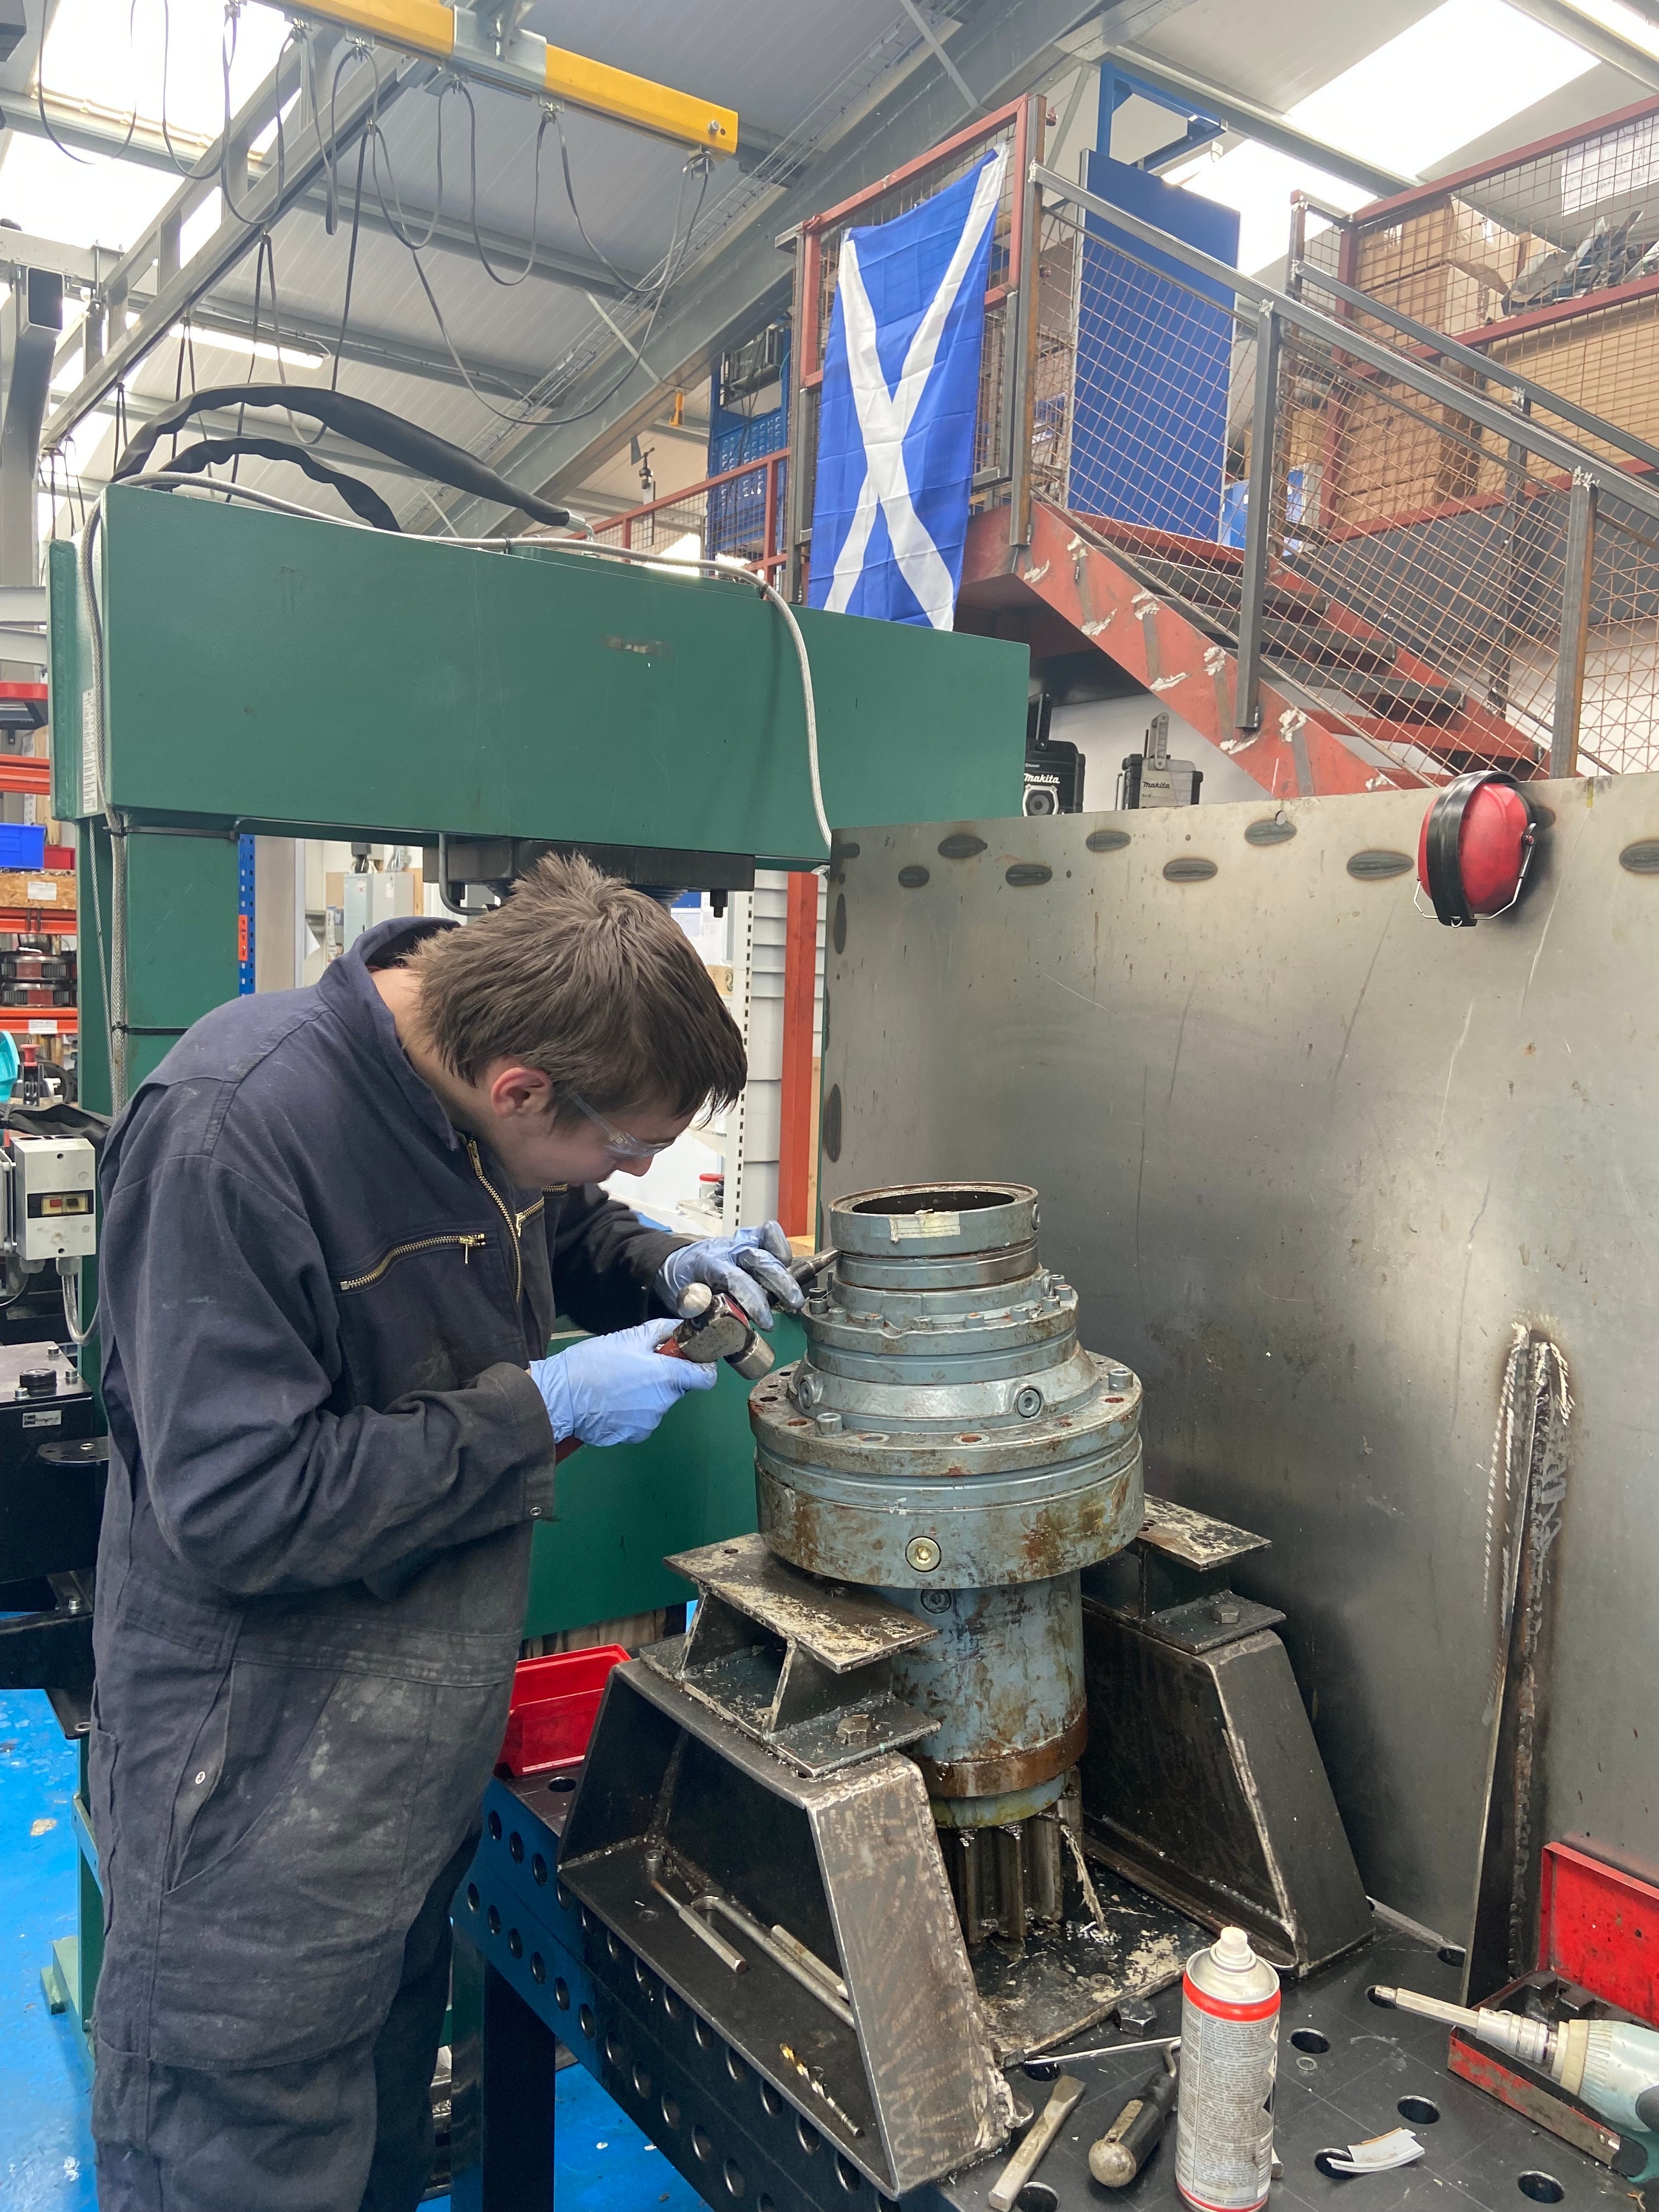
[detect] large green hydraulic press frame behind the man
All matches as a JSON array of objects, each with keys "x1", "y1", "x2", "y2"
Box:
[{"x1": 49, "y1": 484, "x2": 1026, "y2": 2052}]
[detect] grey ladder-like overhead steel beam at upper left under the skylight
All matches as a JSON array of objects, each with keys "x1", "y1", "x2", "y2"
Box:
[{"x1": 42, "y1": 62, "x2": 425, "y2": 447}]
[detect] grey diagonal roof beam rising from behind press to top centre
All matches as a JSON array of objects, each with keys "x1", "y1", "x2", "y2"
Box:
[{"x1": 438, "y1": 0, "x2": 1183, "y2": 535}]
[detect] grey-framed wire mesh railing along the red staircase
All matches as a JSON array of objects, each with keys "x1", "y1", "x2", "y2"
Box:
[{"x1": 1033, "y1": 197, "x2": 1659, "y2": 778}]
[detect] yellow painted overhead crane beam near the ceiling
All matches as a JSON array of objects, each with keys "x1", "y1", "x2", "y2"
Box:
[{"x1": 287, "y1": 0, "x2": 737, "y2": 155}]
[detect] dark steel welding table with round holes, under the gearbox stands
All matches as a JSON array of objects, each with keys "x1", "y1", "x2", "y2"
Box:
[{"x1": 454, "y1": 1760, "x2": 1659, "y2": 2212}]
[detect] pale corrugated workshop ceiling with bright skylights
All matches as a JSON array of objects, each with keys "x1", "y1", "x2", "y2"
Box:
[{"x1": 0, "y1": 0, "x2": 1659, "y2": 533}]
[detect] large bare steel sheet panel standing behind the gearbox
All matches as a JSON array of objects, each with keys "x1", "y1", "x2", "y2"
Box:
[{"x1": 823, "y1": 787, "x2": 1659, "y2": 1931}]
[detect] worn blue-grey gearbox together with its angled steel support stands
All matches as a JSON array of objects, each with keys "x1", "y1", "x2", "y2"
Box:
[{"x1": 560, "y1": 1181, "x2": 1372, "y2": 2197}]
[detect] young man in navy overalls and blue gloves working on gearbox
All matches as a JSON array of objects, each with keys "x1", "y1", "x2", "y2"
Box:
[{"x1": 91, "y1": 860, "x2": 801, "y2": 2212}]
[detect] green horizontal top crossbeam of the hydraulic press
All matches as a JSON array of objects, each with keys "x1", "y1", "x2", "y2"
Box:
[{"x1": 75, "y1": 487, "x2": 1026, "y2": 860}]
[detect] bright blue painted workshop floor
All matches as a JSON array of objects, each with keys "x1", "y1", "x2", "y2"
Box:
[{"x1": 0, "y1": 1690, "x2": 701, "y2": 2212}]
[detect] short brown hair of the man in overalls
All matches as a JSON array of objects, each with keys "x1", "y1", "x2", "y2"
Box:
[{"x1": 416, "y1": 856, "x2": 748, "y2": 1119}]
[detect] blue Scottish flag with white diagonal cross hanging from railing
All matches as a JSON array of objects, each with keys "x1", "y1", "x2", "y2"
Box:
[{"x1": 808, "y1": 148, "x2": 1009, "y2": 630}]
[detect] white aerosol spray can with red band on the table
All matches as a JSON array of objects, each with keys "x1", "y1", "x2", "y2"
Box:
[{"x1": 1175, "y1": 1929, "x2": 1278, "y2": 2212}]
